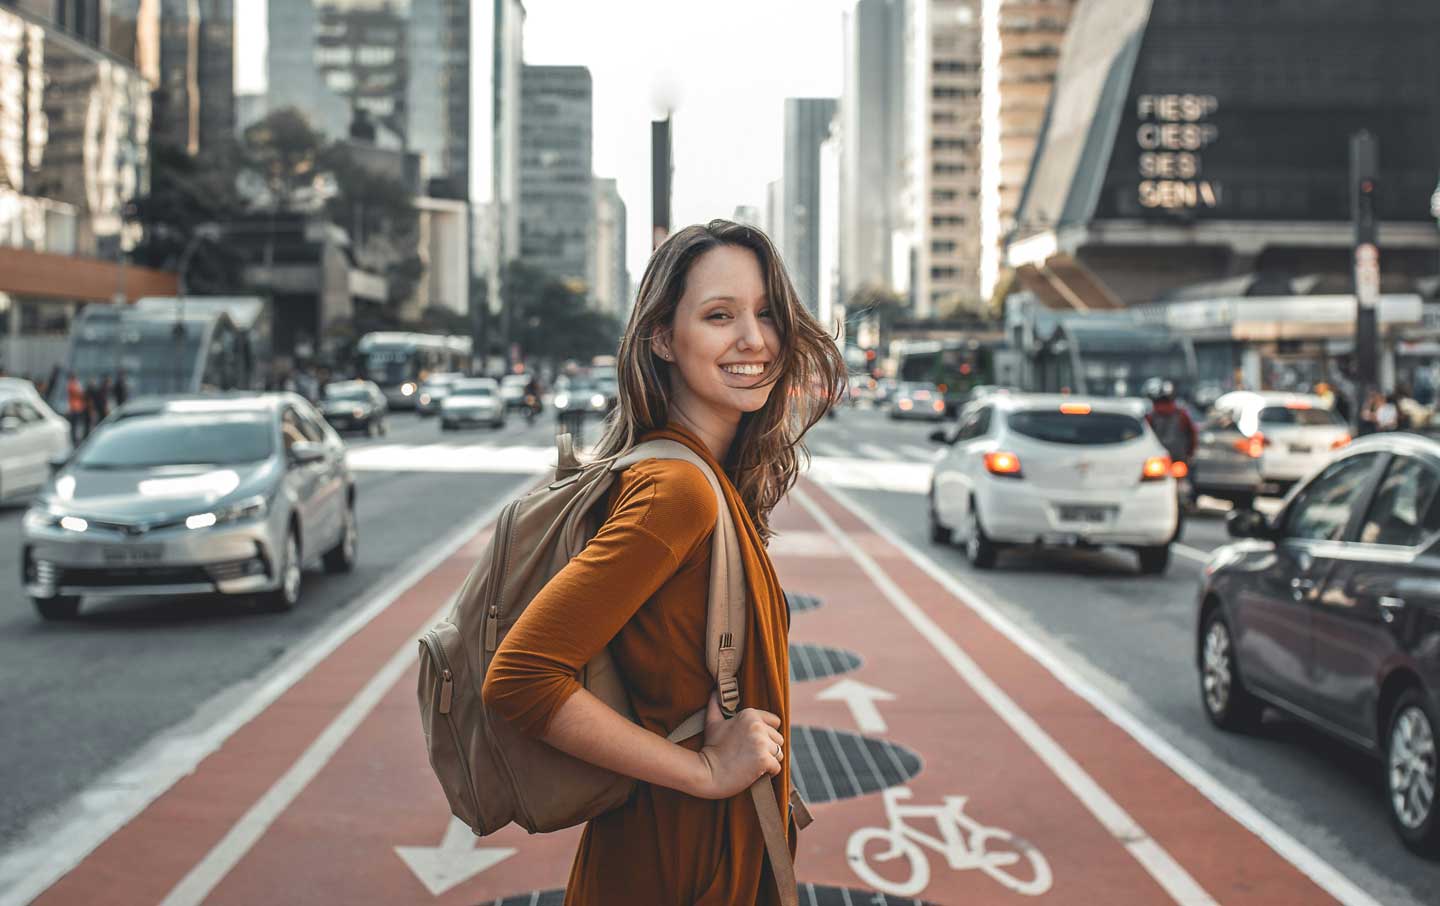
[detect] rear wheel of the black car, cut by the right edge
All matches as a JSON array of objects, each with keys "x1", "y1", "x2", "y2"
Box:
[{"x1": 1385, "y1": 687, "x2": 1440, "y2": 858}]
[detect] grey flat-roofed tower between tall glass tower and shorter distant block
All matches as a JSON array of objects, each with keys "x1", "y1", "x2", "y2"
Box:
[{"x1": 520, "y1": 66, "x2": 595, "y2": 288}]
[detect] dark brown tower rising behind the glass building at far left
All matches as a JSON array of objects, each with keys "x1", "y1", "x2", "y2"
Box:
[{"x1": 107, "y1": 0, "x2": 236, "y2": 154}]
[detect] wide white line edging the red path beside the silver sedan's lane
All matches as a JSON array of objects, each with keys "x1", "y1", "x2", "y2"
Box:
[{"x1": 0, "y1": 481, "x2": 528, "y2": 906}]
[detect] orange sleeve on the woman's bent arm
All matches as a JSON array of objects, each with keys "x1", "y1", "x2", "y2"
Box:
[{"x1": 481, "y1": 459, "x2": 717, "y2": 736}]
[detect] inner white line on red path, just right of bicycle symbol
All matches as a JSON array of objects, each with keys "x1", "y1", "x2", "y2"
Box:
[{"x1": 791, "y1": 488, "x2": 1218, "y2": 906}]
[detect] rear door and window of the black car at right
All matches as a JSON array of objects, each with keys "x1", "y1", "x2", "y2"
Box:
[{"x1": 1310, "y1": 454, "x2": 1440, "y2": 743}]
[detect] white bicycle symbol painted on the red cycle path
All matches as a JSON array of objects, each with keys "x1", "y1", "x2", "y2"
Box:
[{"x1": 845, "y1": 786, "x2": 1053, "y2": 897}]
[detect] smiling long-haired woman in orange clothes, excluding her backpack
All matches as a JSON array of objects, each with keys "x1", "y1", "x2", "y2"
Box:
[{"x1": 484, "y1": 220, "x2": 845, "y2": 906}]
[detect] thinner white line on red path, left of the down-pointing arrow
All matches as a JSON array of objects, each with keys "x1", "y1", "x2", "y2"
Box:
[{"x1": 160, "y1": 596, "x2": 454, "y2": 906}]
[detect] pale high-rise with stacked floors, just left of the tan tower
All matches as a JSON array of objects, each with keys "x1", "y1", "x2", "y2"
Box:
[{"x1": 909, "y1": 0, "x2": 982, "y2": 318}]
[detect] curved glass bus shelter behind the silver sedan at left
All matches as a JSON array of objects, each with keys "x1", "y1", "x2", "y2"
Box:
[{"x1": 49, "y1": 297, "x2": 269, "y2": 412}]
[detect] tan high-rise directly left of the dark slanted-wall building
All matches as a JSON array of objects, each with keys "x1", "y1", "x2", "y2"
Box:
[{"x1": 979, "y1": 0, "x2": 1082, "y2": 300}]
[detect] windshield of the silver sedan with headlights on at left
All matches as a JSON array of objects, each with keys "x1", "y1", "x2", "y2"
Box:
[{"x1": 75, "y1": 412, "x2": 275, "y2": 468}]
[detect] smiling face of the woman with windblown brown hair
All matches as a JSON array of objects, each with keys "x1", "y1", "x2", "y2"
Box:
[{"x1": 652, "y1": 245, "x2": 780, "y2": 421}]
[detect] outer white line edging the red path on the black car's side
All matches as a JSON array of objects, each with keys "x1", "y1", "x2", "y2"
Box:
[{"x1": 795, "y1": 487, "x2": 1384, "y2": 906}]
